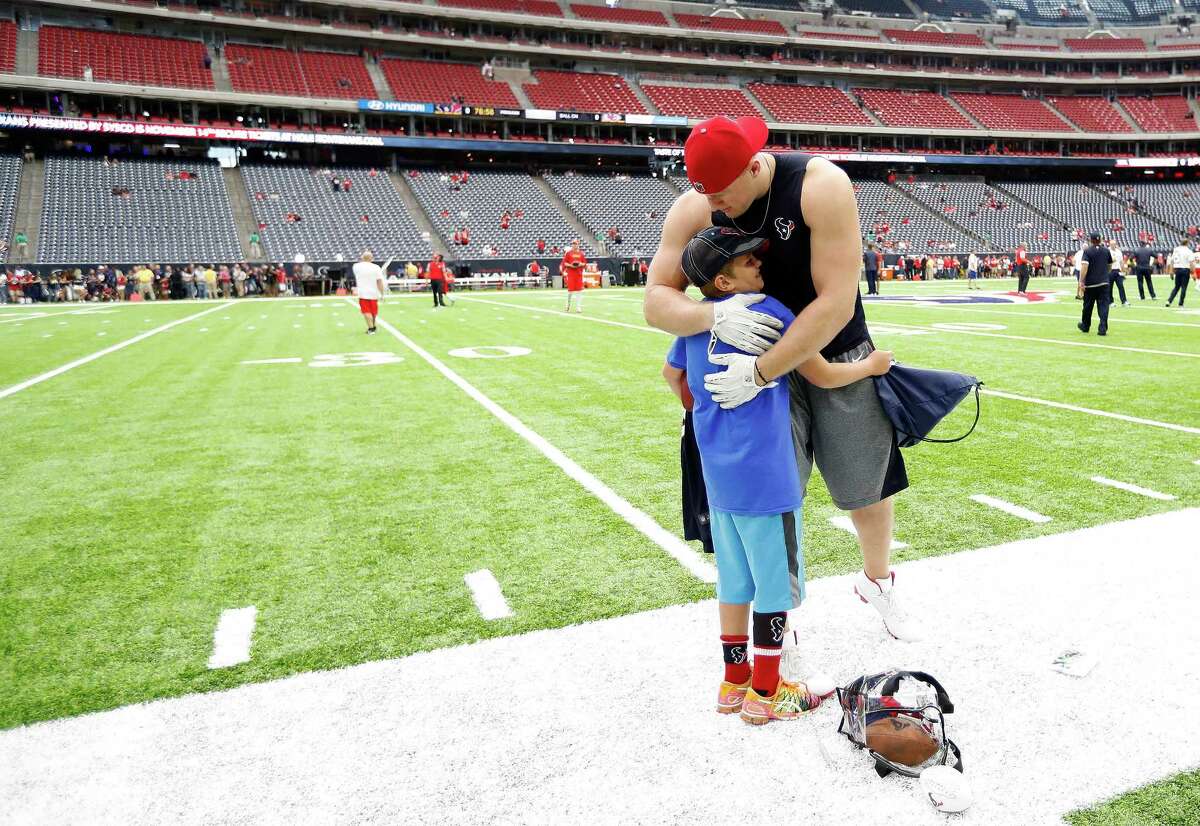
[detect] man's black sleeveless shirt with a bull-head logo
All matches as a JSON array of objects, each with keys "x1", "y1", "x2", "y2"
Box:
[{"x1": 713, "y1": 152, "x2": 870, "y2": 359}]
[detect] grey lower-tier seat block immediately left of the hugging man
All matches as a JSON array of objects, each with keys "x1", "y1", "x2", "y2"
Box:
[{"x1": 545, "y1": 174, "x2": 679, "y2": 257}]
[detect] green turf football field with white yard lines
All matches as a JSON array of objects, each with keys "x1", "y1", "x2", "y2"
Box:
[{"x1": 0, "y1": 279, "x2": 1200, "y2": 822}]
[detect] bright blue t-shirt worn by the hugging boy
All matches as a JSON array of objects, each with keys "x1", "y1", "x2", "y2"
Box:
[{"x1": 667, "y1": 298, "x2": 803, "y2": 515}]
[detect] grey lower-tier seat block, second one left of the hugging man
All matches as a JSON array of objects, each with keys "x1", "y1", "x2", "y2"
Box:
[{"x1": 408, "y1": 172, "x2": 596, "y2": 258}]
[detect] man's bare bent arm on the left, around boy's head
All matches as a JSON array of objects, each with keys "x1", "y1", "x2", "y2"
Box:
[{"x1": 642, "y1": 191, "x2": 713, "y2": 336}]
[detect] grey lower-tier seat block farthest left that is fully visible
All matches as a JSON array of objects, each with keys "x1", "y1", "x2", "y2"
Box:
[{"x1": 37, "y1": 155, "x2": 242, "y2": 264}]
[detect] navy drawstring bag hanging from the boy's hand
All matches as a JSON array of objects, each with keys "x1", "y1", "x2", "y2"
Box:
[{"x1": 874, "y1": 364, "x2": 983, "y2": 448}]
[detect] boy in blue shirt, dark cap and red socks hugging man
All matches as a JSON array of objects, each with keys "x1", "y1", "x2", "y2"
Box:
[{"x1": 662, "y1": 227, "x2": 892, "y2": 725}]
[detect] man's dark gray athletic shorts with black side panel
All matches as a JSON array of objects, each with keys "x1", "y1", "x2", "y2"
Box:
[{"x1": 787, "y1": 341, "x2": 908, "y2": 510}]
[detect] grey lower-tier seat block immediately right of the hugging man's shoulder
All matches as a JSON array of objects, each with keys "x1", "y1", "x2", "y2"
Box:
[{"x1": 853, "y1": 180, "x2": 979, "y2": 253}]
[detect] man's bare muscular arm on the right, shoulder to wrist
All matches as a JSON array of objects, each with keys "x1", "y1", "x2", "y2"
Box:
[{"x1": 758, "y1": 157, "x2": 863, "y2": 381}]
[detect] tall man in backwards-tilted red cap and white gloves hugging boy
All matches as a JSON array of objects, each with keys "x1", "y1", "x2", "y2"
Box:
[{"x1": 643, "y1": 118, "x2": 922, "y2": 640}]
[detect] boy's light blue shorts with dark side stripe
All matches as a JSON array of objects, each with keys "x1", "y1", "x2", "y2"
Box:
[{"x1": 709, "y1": 508, "x2": 804, "y2": 613}]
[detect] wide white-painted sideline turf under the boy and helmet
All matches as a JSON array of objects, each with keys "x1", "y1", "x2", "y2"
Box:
[{"x1": 0, "y1": 509, "x2": 1200, "y2": 826}]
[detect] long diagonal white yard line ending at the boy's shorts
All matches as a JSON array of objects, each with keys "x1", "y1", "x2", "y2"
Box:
[{"x1": 376, "y1": 312, "x2": 716, "y2": 582}]
